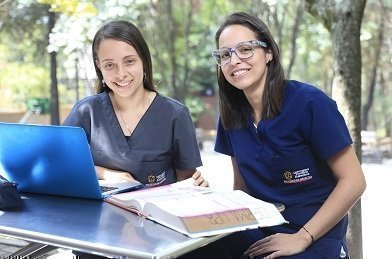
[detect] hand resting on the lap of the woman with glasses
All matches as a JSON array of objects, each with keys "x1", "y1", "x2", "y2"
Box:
[{"x1": 244, "y1": 229, "x2": 312, "y2": 259}]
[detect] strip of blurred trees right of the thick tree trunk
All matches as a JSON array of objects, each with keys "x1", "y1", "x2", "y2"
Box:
[{"x1": 361, "y1": 0, "x2": 392, "y2": 136}]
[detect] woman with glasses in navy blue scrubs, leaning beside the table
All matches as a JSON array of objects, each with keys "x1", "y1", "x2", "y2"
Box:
[{"x1": 185, "y1": 13, "x2": 366, "y2": 259}]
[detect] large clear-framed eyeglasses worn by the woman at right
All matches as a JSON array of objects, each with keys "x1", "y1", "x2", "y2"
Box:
[{"x1": 211, "y1": 40, "x2": 267, "y2": 66}]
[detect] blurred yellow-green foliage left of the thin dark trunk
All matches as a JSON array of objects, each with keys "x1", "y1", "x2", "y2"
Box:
[{"x1": 0, "y1": 1, "x2": 49, "y2": 109}]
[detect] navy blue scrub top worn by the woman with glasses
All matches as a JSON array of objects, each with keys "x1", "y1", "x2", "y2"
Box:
[{"x1": 215, "y1": 81, "x2": 352, "y2": 247}]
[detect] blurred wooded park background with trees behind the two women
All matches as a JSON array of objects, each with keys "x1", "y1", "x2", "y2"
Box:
[{"x1": 0, "y1": 0, "x2": 392, "y2": 259}]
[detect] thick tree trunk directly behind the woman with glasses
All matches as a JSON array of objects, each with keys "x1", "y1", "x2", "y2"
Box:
[{"x1": 307, "y1": 0, "x2": 366, "y2": 259}]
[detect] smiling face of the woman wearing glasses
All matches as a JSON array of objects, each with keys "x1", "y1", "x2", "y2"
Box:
[{"x1": 219, "y1": 25, "x2": 272, "y2": 92}]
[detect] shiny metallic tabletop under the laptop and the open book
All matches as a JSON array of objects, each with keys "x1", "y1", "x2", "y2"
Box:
[{"x1": 0, "y1": 194, "x2": 223, "y2": 258}]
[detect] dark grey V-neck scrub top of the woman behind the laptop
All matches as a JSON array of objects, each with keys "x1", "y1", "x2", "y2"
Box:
[{"x1": 63, "y1": 92, "x2": 202, "y2": 186}]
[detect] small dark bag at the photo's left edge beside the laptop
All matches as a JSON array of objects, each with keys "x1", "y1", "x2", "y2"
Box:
[{"x1": 0, "y1": 175, "x2": 22, "y2": 210}]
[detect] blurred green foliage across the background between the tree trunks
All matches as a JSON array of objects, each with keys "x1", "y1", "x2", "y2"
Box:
[{"x1": 0, "y1": 0, "x2": 392, "y2": 133}]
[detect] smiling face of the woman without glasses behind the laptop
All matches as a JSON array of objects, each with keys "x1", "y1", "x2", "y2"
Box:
[{"x1": 96, "y1": 39, "x2": 144, "y2": 97}]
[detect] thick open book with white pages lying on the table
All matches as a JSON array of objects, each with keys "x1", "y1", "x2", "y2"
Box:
[{"x1": 105, "y1": 180, "x2": 287, "y2": 238}]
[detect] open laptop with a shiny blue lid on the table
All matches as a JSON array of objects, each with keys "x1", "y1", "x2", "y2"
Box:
[{"x1": 0, "y1": 122, "x2": 143, "y2": 199}]
